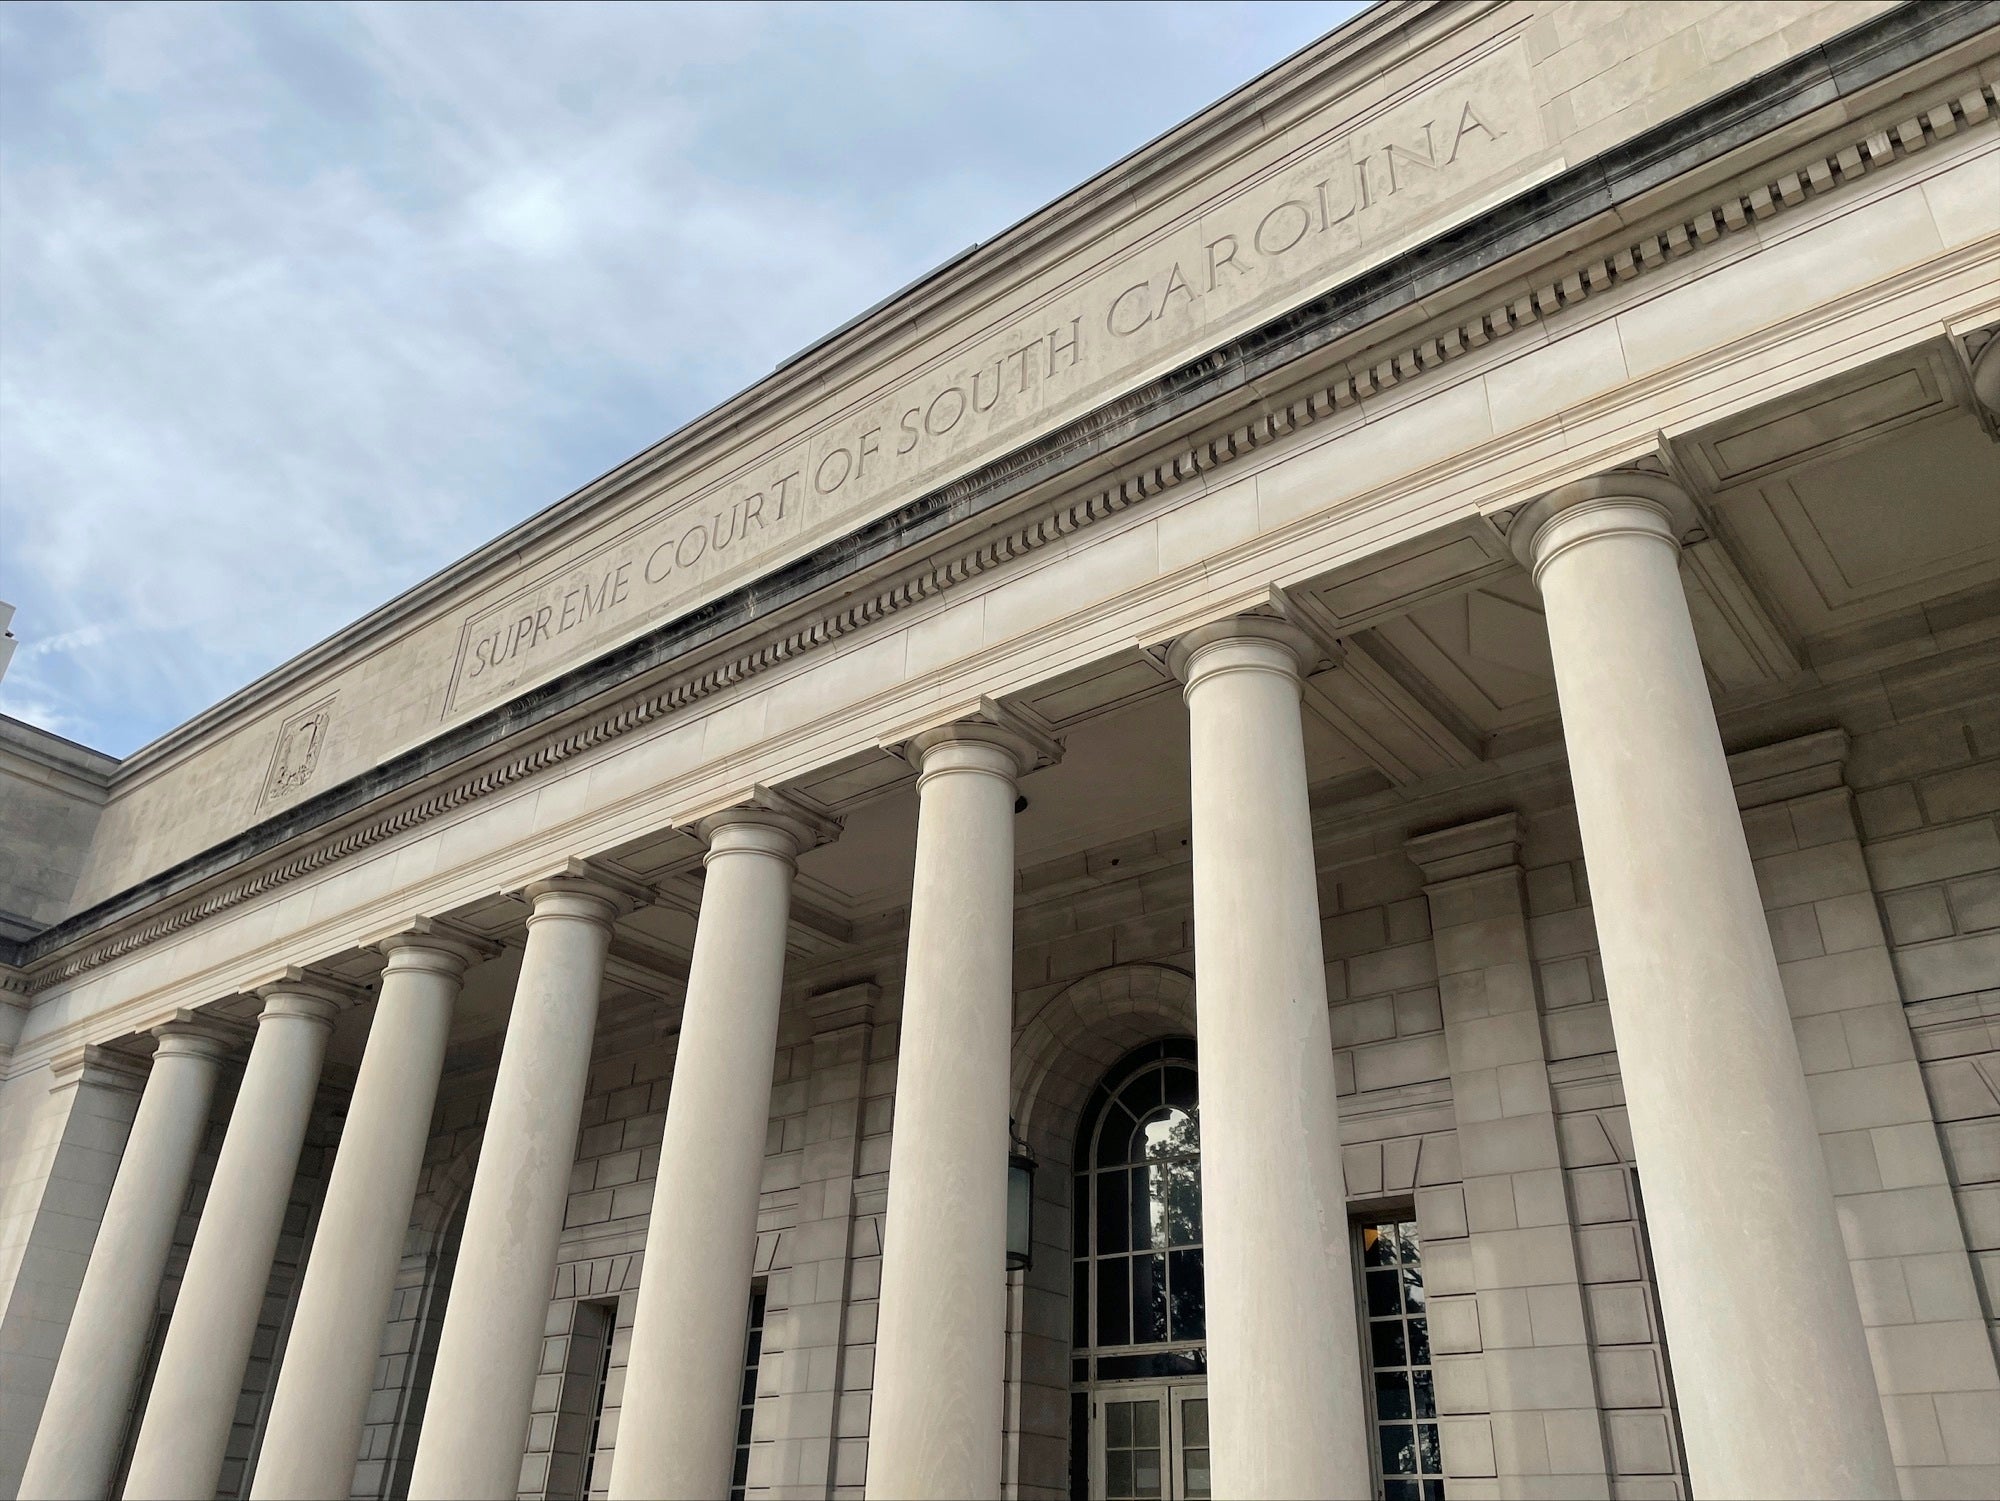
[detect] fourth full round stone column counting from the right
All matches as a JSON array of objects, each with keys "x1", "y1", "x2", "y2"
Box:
[{"x1": 610, "y1": 807, "x2": 826, "y2": 1501}]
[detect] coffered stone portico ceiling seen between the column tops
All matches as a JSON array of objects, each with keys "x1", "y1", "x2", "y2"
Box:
[{"x1": 660, "y1": 340, "x2": 2000, "y2": 933}]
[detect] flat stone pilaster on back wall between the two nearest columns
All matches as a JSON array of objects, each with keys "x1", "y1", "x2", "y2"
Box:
[{"x1": 1408, "y1": 813, "x2": 1608, "y2": 1497}]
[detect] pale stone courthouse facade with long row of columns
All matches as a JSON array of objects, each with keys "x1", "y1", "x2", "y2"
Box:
[{"x1": 0, "y1": 0, "x2": 2000, "y2": 1501}]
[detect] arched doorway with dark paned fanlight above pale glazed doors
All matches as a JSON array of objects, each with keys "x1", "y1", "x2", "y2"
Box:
[{"x1": 1070, "y1": 1039, "x2": 1208, "y2": 1501}]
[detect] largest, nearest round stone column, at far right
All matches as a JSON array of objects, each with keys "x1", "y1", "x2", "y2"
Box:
[{"x1": 1512, "y1": 474, "x2": 1898, "y2": 1497}]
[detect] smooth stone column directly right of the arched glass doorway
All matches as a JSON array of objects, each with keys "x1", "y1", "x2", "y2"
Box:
[{"x1": 1172, "y1": 618, "x2": 1374, "y2": 1497}]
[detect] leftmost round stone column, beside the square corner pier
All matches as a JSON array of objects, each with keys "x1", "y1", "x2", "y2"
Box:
[{"x1": 20, "y1": 1015, "x2": 226, "y2": 1497}]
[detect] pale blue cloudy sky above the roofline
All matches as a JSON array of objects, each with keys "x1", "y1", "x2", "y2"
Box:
[{"x1": 0, "y1": 2, "x2": 1360, "y2": 755}]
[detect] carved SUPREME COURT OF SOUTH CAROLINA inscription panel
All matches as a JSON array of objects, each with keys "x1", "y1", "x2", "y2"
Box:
[{"x1": 444, "y1": 42, "x2": 1544, "y2": 714}]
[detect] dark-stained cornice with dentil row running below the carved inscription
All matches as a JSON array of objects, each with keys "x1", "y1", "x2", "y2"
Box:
[{"x1": 15, "y1": 11, "x2": 2000, "y2": 991}]
